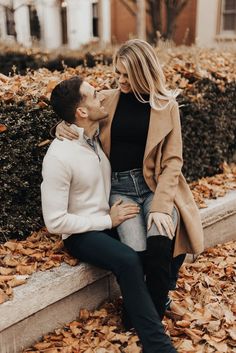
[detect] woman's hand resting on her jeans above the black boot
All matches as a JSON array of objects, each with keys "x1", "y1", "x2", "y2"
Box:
[{"x1": 147, "y1": 212, "x2": 175, "y2": 240}]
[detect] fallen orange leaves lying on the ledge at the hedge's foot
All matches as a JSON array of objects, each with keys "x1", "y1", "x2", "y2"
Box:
[{"x1": 0, "y1": 163, "x2": 236, "y2": 304}]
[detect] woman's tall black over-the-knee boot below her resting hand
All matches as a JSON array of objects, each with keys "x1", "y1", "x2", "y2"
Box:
[{"x1": 146, "y1": 235, "x2": 172, "y2": 320}]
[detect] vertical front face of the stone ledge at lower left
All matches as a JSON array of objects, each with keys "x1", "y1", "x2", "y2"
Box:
[{"x1": 0, "y1": 276, "x2": 120, "y2": 353}]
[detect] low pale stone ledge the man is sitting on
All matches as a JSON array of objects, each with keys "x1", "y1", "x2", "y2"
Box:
[{"x1": 0, "y1": 191, "x2": 236, "y2": 353}]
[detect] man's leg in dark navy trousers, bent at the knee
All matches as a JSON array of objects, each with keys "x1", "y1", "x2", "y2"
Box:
[{"x1": 64, "y1": 231, "x2": 176, "y2": 353}]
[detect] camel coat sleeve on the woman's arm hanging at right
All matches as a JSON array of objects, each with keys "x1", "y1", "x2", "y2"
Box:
[{"x1": 151, "y1": 102, "x2": 183, "y2": 216}]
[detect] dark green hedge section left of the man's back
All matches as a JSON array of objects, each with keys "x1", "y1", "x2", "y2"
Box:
[{"x1": 0, "y1": 102, "x2": 56, "y2": 241}]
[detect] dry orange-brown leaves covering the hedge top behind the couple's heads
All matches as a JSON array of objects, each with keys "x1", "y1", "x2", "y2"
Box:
[{"x1": 0, "y1": 47, "x2": 236, "y2": 107}]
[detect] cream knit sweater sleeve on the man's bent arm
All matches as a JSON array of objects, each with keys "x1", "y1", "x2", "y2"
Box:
[{"x1": 41, "y1": 155, "x2": 112, "y2": 234}]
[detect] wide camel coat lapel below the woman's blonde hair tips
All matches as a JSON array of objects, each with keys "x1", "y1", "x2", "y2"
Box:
[{"x1": 144, "y1": 104, "x2": 173, "y2": 160}]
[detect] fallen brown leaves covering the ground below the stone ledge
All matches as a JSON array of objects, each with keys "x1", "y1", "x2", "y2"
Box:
[{"x1": 21, "y1": 242, "x2": 236, "y2": 353}]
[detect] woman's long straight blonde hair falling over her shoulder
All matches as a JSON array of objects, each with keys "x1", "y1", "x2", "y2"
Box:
[{"x1": 114, "y1": 39, "x2": 179, "y2": 110}]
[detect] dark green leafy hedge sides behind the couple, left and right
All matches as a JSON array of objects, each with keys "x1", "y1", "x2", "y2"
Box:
[{"x1": 0, "y1": 79, "x2": 236, "y2": 241}]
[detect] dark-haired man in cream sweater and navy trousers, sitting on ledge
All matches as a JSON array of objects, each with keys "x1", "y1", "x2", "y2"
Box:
[{"x1": 41, "y1": 77, "x2": 176, "y2": 353}]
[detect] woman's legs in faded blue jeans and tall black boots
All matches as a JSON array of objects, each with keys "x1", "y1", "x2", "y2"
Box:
[{"x1": 110, "y1": 169, "x2": 185, "y2": 318}]
